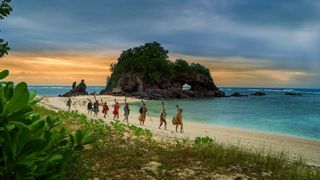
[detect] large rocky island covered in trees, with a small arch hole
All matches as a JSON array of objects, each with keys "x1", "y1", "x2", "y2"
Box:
[{"x1": 100, "y1": 42, "x2": 225, "y2": 99}]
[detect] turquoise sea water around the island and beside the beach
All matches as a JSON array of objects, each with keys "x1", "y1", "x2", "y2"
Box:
[{"x1": 30, "y1": 86, "x2": 320, "y2": 140}]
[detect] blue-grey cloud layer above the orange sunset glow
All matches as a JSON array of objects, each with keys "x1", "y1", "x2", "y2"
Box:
[{"x1": 1, "y1": 0, "x2": 320, "y2": 71}]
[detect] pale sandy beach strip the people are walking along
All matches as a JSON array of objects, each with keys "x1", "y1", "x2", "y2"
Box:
[{"x1": 39, "y1": 95, "x2": 320, "y2": 166}]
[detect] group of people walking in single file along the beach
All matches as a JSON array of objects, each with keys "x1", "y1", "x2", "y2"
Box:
[{"x1": 67, "y1": 97, "x2": 183, "y2": 133}]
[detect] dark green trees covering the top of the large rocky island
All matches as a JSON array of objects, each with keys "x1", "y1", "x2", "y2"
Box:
[{"x1": 108, "y1": 42, "x2": 212, "y2": 89}]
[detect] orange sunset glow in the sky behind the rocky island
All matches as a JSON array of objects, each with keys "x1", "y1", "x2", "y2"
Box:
[{"x1": 2, "y1": 52, "x2": 313, "y2": 87}]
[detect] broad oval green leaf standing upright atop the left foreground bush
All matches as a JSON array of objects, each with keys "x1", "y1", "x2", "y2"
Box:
[{"x1": 5, "y1": 82, "x2": 29, "y2": 113}]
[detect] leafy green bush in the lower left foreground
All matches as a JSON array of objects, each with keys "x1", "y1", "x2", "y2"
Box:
[{"x1": 0, "y1": 70, "x2": 91, "y2": 179}]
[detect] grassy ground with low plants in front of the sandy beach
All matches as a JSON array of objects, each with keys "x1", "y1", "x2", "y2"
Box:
[{"x1": 35, "y1": 106, "x2": 320, "y2": 179}]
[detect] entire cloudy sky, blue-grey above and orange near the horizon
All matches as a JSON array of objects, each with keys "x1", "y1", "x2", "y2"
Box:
[{"x1": 0, "y1": 0, "x2": 320, "y2": 87}]
